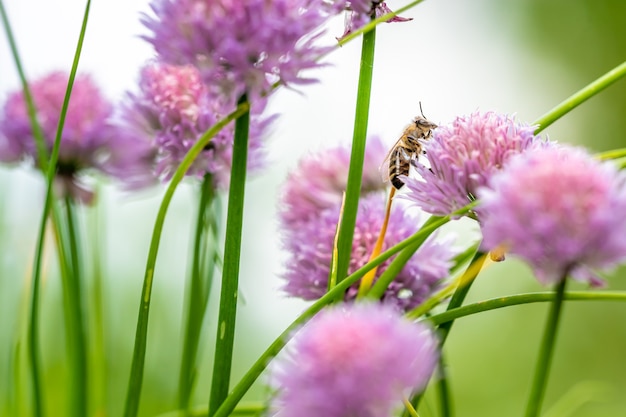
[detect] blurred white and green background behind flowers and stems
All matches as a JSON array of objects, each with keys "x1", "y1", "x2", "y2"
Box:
[{"x1": 0, "y1": 0, "x2": 626, "y2": 417}]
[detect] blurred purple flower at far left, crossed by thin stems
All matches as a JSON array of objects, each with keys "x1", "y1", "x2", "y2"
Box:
[{"x1": 0, "y1": 71, "x2": 155, "y2": 203}]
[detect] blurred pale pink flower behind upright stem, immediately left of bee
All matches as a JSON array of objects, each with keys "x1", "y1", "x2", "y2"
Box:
[{"x1": 279, "y1": 136, "x2": 388, "y2": 229}]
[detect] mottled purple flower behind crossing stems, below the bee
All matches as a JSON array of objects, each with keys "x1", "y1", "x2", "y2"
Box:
[{"x1": 283, "y1": 191, "x2": 457, "y2": 311}]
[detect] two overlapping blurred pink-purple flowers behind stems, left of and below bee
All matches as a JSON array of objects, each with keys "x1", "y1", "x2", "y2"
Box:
[{"x1": 280, "y1": 138, "x2": 456, "y2": 311}]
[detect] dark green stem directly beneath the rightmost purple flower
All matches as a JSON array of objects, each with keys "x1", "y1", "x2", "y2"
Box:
[{"x1": 526, "y1": 274, "x2": 567, "y2": 417}]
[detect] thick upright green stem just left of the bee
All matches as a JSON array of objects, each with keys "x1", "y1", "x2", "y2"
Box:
[{"x1": 337, "y1": 29, "x2": 376, "y2": 282}]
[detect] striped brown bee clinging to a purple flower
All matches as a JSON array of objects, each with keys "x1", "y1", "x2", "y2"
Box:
[{"x1": 381, "y1": 108, "x2": 437, "y2": 190}]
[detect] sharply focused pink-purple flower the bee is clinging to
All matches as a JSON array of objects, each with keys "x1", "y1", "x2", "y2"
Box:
[{"x1": 401, "y1": 112, "x2": 551, "y2": 216}]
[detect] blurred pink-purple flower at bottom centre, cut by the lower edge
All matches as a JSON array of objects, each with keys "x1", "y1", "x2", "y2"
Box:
[{"x1": 270, "y1": 304, "x2": 438, "y2": 417}]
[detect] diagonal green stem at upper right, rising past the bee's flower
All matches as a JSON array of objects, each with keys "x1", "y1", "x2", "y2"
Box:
[{"x1": 533, "y1": 62, "x2": 626, "y2": 134}]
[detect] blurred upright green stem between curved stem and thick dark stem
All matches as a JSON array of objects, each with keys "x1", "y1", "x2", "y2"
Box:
[{"x1": 178, "y1": 174, "x2": 215, "y2": 413}]
